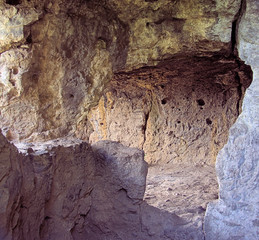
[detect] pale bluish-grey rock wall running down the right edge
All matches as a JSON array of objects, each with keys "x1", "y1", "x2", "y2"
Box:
[{"x1": 205, "y1": 0, "x2": 259, "y2": 240}]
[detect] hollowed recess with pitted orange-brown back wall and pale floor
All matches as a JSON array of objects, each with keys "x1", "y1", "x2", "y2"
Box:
[{"x1": 88, "y1": 55, "x2": 251, "y2": 224}]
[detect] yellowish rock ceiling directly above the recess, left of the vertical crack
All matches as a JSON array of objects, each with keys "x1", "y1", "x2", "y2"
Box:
[{"x1": 110, "y1": 0, "x2": 241, "y2": 69}]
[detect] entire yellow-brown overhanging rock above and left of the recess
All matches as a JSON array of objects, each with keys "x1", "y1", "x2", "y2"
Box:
[{"x1": 0, "y1": 0, "x2": 247, "y2": 141}]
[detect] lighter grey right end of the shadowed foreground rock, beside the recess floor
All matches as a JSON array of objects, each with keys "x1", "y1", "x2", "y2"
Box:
[{"x1": 92, "y1": 141, "x2": 148, "y2": 200}]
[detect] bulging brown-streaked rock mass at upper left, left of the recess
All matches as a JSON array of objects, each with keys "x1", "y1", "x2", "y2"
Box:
[{"x1": 0, "y1": 1, "x2": 127, "y2": 141}]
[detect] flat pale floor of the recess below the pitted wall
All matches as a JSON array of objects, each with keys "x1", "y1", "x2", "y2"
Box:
[{"x1": 144, "y1": 164, "x2": 218, "y2": 225}]
